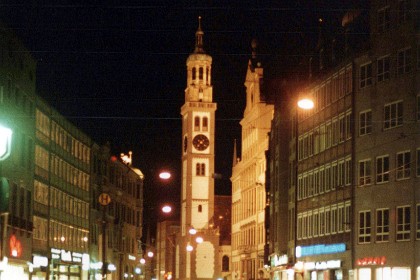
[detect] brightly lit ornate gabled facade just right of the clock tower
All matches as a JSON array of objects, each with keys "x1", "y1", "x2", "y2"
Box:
[{"x1": 231, "y1": 41, "x2": 274, "y2": 279}]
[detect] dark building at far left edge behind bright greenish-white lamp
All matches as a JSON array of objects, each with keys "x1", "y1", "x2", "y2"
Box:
[{"x1": 0, "y1": 22, "x2": 36, "y2": 279}]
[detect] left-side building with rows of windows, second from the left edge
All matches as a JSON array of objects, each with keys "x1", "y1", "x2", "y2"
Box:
[{"x1": 33, "y1": 100, "x2": 92, "y2": 279}]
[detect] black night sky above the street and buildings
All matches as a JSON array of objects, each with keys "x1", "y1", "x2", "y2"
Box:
[{"x1": 0, "y1": 0, "x2": 363, "y2": 233}]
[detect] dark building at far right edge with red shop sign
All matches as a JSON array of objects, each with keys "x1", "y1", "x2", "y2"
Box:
[{"x1": 354, "y1": 0, "x2": 420, "y2": 280}]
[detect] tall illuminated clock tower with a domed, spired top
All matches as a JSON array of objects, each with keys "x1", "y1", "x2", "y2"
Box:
[{"x1": 177, "y1": 17, "x2": 220, "y2": 279}]
